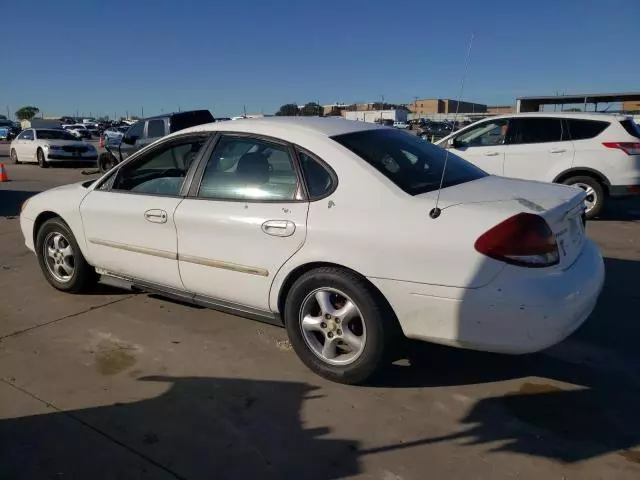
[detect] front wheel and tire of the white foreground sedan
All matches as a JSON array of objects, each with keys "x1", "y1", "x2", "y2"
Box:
[{"x1": 36, "y1": 217, "x2": 98, "y2": 293}]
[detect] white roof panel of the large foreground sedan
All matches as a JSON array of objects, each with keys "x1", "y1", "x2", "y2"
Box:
[{"x1": 174, "y1": 117, "x2": 385, "y2": 137}]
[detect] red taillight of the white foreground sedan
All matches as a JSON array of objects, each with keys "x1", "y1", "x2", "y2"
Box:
[{"x1": 475, "y1": 213, "x2": 560, "y2": 268}]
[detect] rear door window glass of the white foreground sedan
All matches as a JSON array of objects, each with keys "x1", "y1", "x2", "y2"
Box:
[{"x1": 198, "y1": 136, "x2": 298, "y2": 201}]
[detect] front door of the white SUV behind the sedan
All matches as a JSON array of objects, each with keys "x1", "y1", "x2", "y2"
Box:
[{"x1": 448, "y1": 119, "x2": 509, "y2": 175}]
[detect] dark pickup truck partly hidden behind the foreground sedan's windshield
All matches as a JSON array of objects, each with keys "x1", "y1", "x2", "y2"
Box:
[{"x1": 98, "y1": 110, "x2": 215, "y2": 172}]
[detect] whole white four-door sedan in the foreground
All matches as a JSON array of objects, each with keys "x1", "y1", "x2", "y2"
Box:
[{"x1": 20, "y1": 117, "x2": 604, "y2": 383}]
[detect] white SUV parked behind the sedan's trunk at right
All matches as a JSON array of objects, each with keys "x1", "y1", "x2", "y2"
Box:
[{"x1": 437, "y1": 113, "x2": 640, "y2": 218}]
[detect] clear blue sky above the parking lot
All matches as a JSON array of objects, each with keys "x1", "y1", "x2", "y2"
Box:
[{"x1": 0, "y1": 0, "x2": 640, "y2": 116}]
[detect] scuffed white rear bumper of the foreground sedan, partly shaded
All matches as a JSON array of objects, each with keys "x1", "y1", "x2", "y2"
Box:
[{"x1": 370, "y1": 240, "x2": 605, "y2": 354}]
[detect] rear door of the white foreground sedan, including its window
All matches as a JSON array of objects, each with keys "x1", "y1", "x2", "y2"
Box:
[{"x1": 175, "y1": 134, "x2": 308, "y2": 311}]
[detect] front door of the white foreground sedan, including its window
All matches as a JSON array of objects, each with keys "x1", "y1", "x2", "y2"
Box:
[{"x1": 80, "y1": 134, "x2": 208, "y2": 290}]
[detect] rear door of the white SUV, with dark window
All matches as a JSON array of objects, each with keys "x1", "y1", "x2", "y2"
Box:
[{"x1": 504, "y1": 116, "x2": 574, "y2": 182}]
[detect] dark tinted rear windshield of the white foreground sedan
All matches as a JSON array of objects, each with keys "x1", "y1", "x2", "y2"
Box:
[{"x1": 332, "y1": 129, "x2": 487, "y2": 195}]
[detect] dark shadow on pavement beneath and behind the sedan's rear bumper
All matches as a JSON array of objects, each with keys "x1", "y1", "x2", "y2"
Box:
[{"x1": 376, "y1": 258, "x2": 640, "y2": 471}]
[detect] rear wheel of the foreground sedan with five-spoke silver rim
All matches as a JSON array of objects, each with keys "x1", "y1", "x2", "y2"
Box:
[{"x1": 284, "y1": 267, "x2": 399, "y2": 384}]
